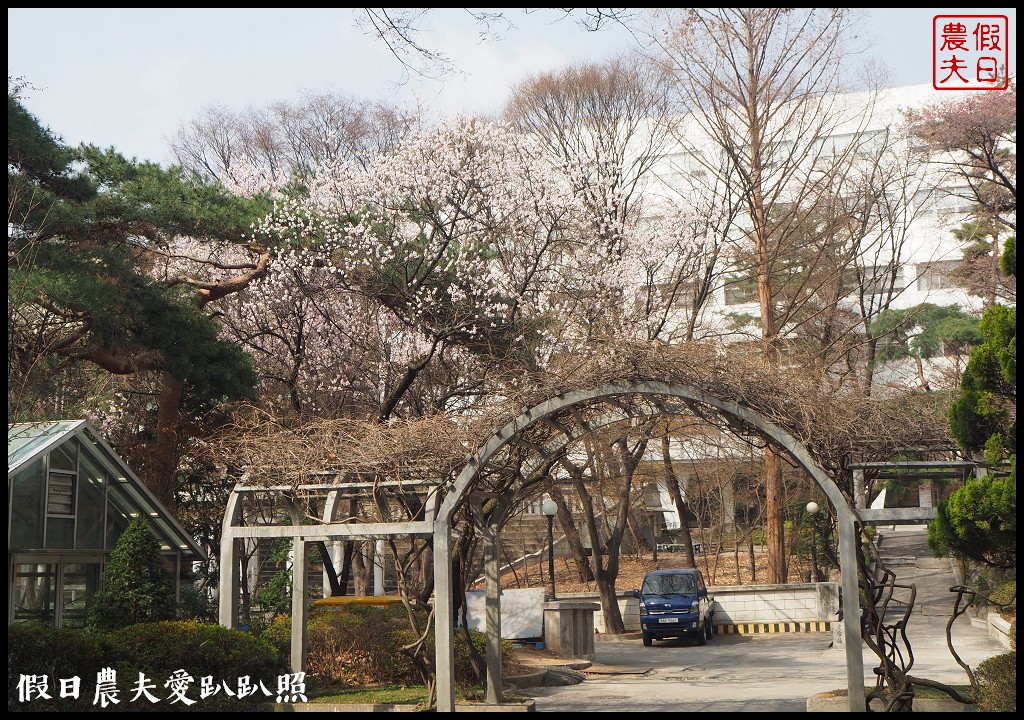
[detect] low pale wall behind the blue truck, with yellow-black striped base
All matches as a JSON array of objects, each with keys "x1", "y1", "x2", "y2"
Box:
[{"x1": 558, "y1": 583, "x2": 839, "y2": 634}]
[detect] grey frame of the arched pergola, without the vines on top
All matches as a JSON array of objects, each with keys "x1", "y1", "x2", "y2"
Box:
[{"x1": 220, "y1": 379, "x2": 962, "y2": 712}]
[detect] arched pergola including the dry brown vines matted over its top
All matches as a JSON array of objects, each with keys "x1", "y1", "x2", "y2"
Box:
[{"x1": 220, "y1": 356, "x2": 944, "y2": 712}]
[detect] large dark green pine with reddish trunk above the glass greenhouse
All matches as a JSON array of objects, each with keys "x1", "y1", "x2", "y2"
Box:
[{"x1": 7, "y1": 90, "x2": 270, "y2": 506}]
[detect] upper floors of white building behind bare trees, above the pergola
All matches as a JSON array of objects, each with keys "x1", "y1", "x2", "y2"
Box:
[{"x1": 647, "y1": 85, "x2": 999, "y2": 391}]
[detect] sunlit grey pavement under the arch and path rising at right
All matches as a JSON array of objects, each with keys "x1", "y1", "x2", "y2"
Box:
[{"x1": 520, "y1": 526, "x2": 1007, "y2": 712}]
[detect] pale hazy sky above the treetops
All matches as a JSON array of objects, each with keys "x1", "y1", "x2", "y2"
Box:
[{"x1": 7, "y1": 7, "x2": 1017, "y2": 164}]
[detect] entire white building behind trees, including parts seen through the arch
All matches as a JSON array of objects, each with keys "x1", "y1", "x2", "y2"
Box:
[{"x1": 548, "y1": 80, "x2": 1011, "y2": 531}]
